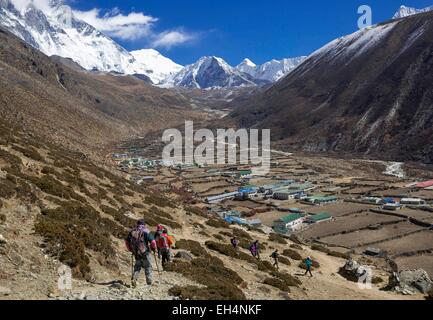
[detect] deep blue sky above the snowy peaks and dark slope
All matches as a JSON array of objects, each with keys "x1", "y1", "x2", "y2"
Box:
[{"x1": 70, "y1": 0, "x2": 433, "y2": 65}]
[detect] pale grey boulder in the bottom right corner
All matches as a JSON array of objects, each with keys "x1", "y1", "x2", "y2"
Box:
[{"x1": 388, "y1": 269, "x2": 433, "y2": 294}]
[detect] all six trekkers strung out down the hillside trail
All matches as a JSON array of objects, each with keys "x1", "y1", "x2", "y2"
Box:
[{"x1": 125, "y1": 220, "x2": 313, "y2": 288}]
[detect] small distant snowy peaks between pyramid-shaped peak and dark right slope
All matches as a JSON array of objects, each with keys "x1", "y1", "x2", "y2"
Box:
[{"x1": 236, "y1": 57, "x2": 307, "y2": 83}]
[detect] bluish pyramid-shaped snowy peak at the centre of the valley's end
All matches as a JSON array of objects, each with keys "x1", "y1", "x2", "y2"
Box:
[{"x1": 166, "y1": 57, "x2": 257, "y2": 89}]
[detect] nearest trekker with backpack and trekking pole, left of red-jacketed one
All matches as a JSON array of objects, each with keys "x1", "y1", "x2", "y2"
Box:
[{"x1": 125, "y1": 220, "x2": 156, "y2": 288}]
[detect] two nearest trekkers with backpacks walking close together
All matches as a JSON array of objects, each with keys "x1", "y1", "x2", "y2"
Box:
[{"x1": 125, "y1": 220, "x2": 174, "y2": 288}]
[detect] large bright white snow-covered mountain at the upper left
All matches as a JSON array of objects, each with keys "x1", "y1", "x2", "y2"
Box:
[{"x1": 0, "y1": 0, "x2": 182, "y2": 84}]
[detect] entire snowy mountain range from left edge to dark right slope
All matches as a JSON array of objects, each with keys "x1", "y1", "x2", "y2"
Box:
[{"x1": 0, "y1": 0, "x2": 304, "y2": 89}]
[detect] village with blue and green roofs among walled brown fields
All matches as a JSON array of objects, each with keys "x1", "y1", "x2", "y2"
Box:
[{"x1": 112, "y1": 141, "x2": 433, "y2": 286}]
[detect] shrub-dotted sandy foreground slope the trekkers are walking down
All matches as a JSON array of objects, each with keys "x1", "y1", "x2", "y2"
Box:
[{"x1": 0, "y1": 117, "x2": 422, "y2": 300}]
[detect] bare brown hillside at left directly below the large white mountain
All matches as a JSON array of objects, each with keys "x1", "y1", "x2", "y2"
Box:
[{"x1": 0, "y1": 25, "x2": 201, "y2": 158}]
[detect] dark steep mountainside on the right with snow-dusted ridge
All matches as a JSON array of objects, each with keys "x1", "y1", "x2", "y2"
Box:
[{"x1": 227, "y1": 12, "x2": 433, "y2": 163}]
